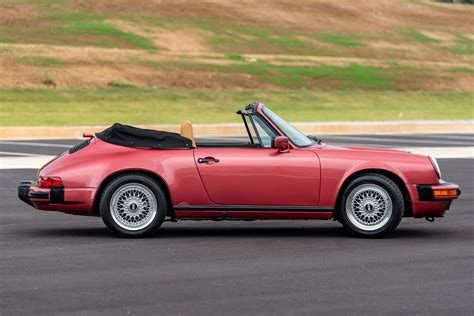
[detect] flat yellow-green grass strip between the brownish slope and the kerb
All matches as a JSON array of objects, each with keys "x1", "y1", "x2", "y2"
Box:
[{"x1": 0, "y1": 87, "x2": 474, "y2": 126}]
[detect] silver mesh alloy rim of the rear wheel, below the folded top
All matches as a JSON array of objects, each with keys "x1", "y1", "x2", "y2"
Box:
[{"x1": 110, "y1": 183, "x2": 158, "y2": 231}]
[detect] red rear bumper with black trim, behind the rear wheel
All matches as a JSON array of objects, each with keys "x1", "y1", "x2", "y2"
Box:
[{"x1": 18, "y1": 181, "x2": 96, "y2": 214}]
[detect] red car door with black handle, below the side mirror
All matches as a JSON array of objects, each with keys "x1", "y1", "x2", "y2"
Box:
[{"x1": 194, "y1": 148, "x2": 320, "y2": 206}]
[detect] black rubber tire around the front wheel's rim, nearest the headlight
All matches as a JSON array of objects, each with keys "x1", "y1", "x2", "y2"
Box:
[{"x1": 339, "y1": 174, "x2": 405, "y2": 237}]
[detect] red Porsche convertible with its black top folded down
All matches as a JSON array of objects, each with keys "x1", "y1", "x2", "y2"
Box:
[{"x1": 18, "y1": 103, "x2": 460, "y2": 237}]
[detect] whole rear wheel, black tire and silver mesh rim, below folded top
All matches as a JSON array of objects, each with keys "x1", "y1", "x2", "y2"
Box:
[{"x1": 99, "y1": 173, "x2": 168, "y2": 237}]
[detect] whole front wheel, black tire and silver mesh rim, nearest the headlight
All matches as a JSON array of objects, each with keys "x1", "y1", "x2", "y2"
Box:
[{"x1": 337, "y1": 173, "x2": 405, "y2": 238}]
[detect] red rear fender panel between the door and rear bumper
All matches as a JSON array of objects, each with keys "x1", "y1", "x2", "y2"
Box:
[{"x1": 40, "y1": 140, "x2": 211, "y2": 205}]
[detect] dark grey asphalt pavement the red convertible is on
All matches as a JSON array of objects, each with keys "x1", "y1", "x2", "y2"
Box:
[{"x1": 0, "y1": 135, "x2": 474, "y2": 315}]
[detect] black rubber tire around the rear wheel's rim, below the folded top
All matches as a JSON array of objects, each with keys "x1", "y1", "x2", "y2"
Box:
[{"x1": 99, "y1": 174, "x2": 167, "y2": 237}]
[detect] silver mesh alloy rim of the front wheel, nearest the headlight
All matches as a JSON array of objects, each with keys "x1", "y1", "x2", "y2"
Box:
[{"x1": 346, "y1": 184, "x2": 393, "y2": 231}]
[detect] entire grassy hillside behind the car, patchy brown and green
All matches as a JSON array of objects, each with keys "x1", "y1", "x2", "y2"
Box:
[{"x1": 0, "y1": 0, "x2": 474, "y2": 126}]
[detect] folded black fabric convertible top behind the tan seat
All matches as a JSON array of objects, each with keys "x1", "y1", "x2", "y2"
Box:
[{"x1": 95, "y1": 123, "x2": 192, "y2": 149}]
